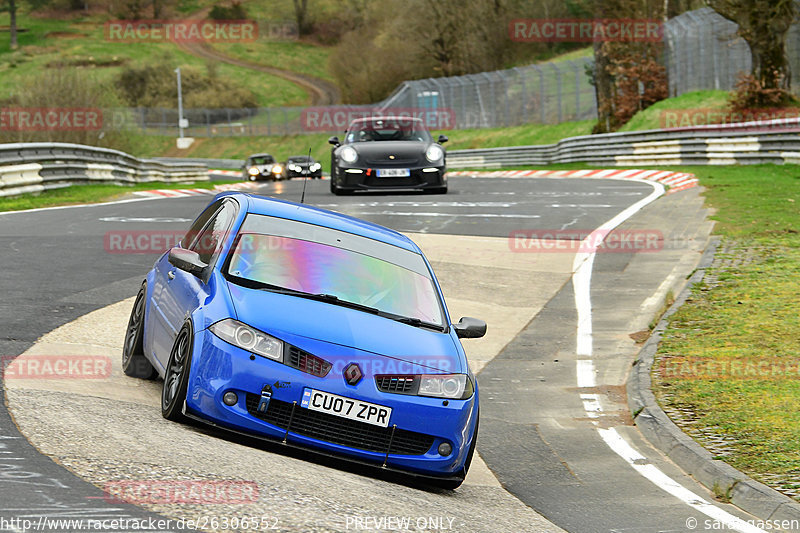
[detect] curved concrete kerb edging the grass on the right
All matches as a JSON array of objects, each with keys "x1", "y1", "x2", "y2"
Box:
[{"x1": 626, "y1": 237, "x2": 800, "y2": 521}]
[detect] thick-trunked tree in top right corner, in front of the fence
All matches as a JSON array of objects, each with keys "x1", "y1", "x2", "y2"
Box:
[{"x1": 706, "y1": 0, "x2": 797, "y2": 91}]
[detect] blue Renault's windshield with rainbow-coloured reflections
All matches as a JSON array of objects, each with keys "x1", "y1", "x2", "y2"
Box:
[{"x1": 226, "y1": 214, "x2": 444, "y2": 327}]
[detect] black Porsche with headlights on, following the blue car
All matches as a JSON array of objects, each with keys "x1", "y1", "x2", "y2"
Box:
[{"x1": 328, "y1": 117, "x2": 447, "y2": 195}]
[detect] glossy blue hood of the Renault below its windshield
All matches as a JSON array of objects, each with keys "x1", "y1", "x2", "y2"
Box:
[{"x1": 228, "y1": 283, "x2": 465, "y2": 372}]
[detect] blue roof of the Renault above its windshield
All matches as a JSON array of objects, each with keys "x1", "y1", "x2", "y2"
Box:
[{"x1": 215, "y1": 192, "x2": 421, "y2": 253}]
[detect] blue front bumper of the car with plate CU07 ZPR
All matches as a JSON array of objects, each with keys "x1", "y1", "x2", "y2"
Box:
[{"x1": 186, "y1": 330, "x2": 478, "y2": 477}]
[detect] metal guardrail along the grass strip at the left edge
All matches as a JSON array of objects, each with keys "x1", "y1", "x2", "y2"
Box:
[{"x1": 0, "y1": 143, "x2": 208, "y2": 196}]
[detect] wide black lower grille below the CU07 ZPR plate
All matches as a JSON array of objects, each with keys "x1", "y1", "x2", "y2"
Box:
[{"x1": 247, "y1": 393, "x2": 433, "y2": 455}]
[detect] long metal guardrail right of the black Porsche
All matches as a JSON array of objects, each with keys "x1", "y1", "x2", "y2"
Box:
[{"x1": 447, "y1": 118, "x2": 800, "y2": 169}]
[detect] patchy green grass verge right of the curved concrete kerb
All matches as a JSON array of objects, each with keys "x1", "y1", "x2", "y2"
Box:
[{"x1": 654, "y1": 165, "x2": 800, "y2": 489}]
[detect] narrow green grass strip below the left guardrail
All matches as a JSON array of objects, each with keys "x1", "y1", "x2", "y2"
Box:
[{"x1": 0, "y1": 180, "x2": 231, "y2": 212}]
